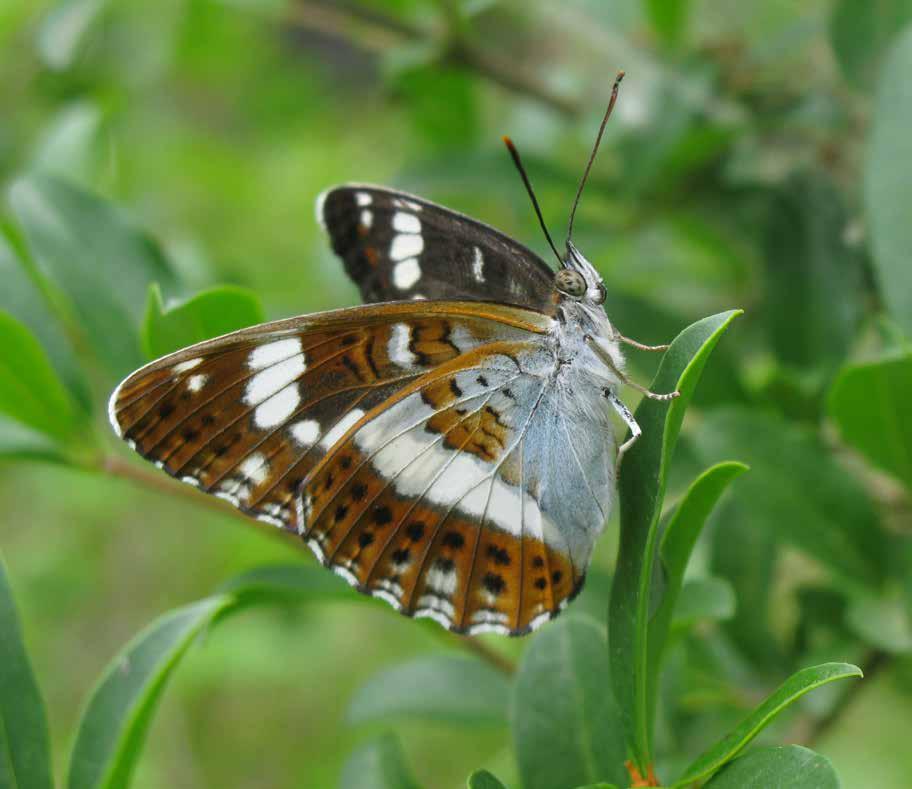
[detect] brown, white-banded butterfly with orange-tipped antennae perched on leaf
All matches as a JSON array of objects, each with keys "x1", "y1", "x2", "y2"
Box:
[{"x1": 109, "y1": 75, "x2": 677, "y2": 635}]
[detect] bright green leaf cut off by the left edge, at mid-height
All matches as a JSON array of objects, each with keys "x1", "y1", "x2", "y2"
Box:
[{"x1": 0, "y1": 310, "x2": 77, "y2": 442}]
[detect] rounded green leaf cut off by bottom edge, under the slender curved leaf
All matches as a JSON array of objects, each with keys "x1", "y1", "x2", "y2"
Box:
[{"x1": 706, "y1": 745, "x2": 840, "y2": 789}]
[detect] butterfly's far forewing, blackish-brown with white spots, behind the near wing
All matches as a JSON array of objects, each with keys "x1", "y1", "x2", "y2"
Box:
[{"x1": 317, "y1": 184, "x2": 554, "y2": 310}]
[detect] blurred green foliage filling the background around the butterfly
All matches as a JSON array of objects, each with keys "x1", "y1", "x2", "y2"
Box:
[{"x1": 0, "y1": 0, "x2": 912, "y2": 789}]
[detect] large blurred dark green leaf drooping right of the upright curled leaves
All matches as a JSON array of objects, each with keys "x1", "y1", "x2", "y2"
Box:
[{"x1": 693, "y1": 408, "x2": 888, "y2": 589}]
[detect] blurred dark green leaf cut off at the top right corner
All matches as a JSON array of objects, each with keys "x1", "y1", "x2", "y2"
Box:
[{"x1": 830, "y1": 0, "x2": 912, "y2": 91}]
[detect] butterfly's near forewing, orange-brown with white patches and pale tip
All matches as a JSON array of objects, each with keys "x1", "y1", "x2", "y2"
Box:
[{"x1": 110, "y1": 303, "x2": 534, "y2": 530}]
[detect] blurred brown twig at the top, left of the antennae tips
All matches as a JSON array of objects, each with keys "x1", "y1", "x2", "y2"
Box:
[{"x1": 286, "y1": 0, "x2": 580, "y2": 116}]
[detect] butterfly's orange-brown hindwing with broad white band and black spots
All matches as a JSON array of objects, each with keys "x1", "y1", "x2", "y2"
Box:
[{"x1": 302, "y1": 343, "x2": 597, "y2": 634}]
